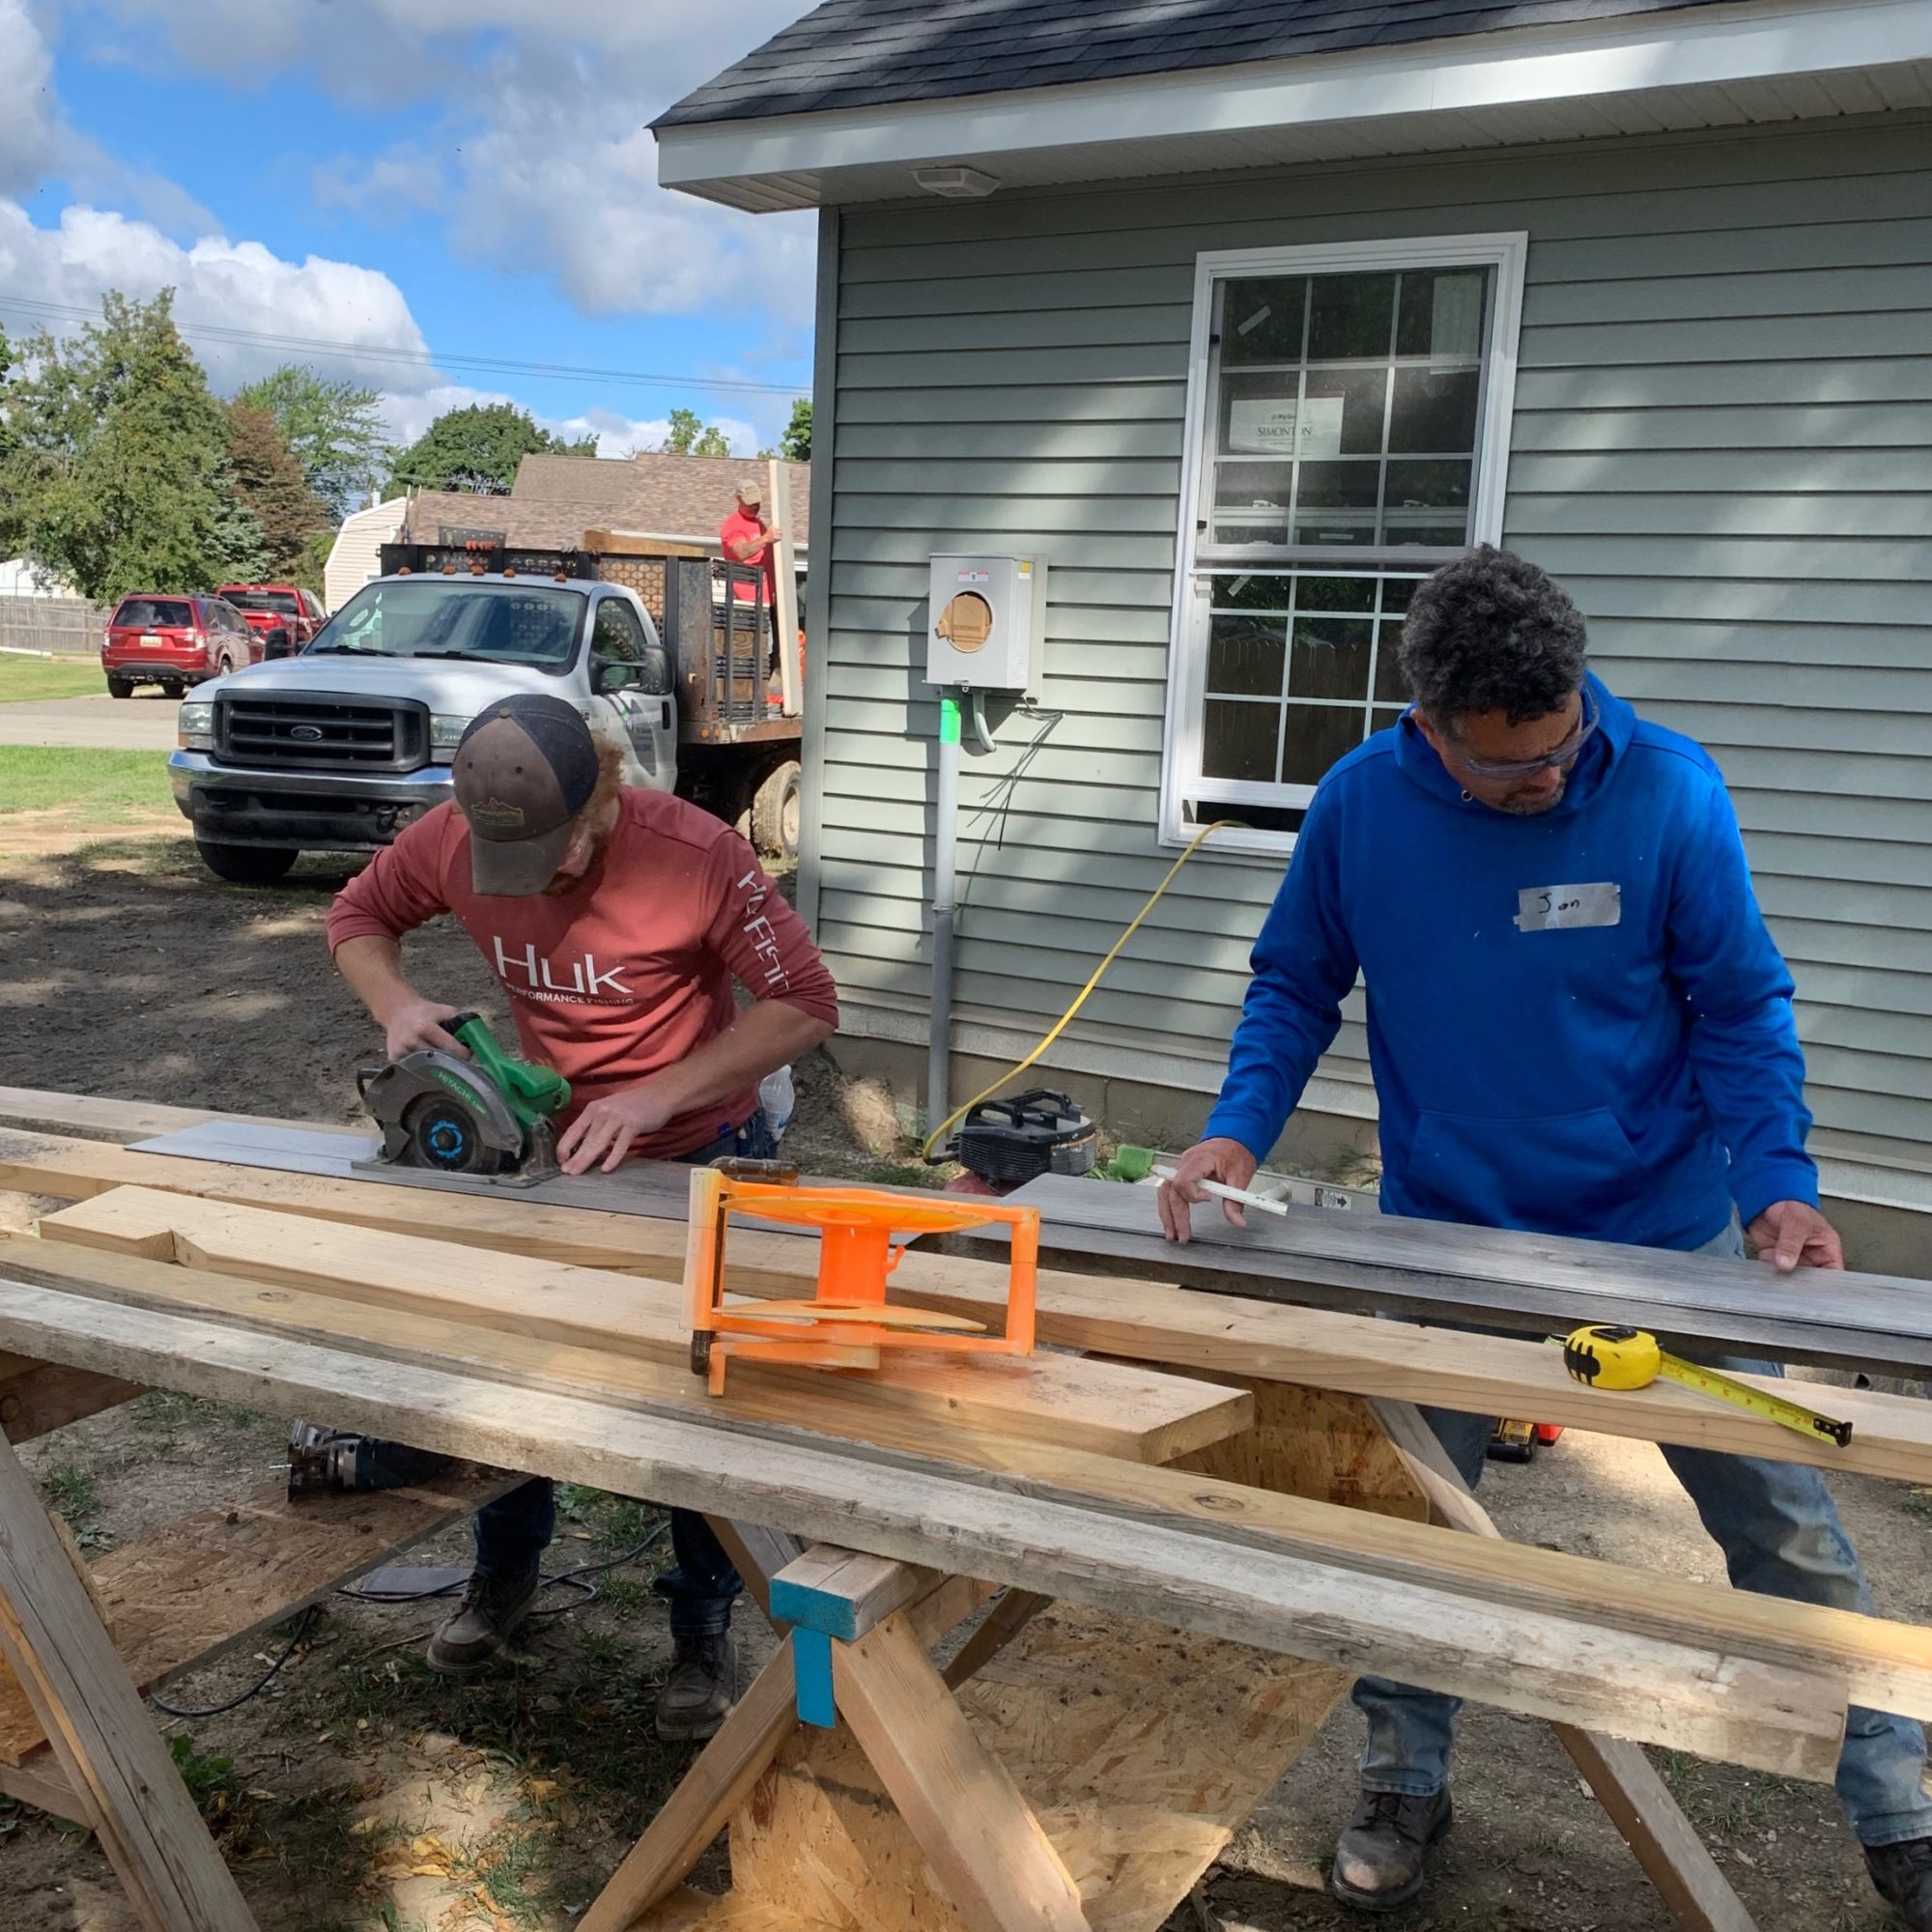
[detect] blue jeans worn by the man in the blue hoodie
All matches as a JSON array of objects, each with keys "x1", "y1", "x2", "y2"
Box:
[{"x1": 1354, "y1": 1225, "x2": 1932, "y2": 1845}]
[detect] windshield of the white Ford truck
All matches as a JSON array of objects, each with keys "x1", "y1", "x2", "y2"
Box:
[{"x1": 309, "y1": 578, "x2": 585, "y2": 670}]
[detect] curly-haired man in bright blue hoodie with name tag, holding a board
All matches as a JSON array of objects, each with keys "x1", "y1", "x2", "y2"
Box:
[{"x1": 1161, "y1": 545, "x2": 1932, "y2": 1932}]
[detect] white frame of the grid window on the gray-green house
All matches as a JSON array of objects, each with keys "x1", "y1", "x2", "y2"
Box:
[{"x1": 1159, "y1": 230, "x2": 1530, "y2": 854}]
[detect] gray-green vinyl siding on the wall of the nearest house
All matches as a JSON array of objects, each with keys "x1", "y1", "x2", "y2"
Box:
[{"x1": 813, "y1": 116, "x2": 1932, "y2": 1161}]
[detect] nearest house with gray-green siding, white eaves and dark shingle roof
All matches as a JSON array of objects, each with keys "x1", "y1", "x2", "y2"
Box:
[{"x1": 657, "y1": 0, "x2": 1932, "y2": 1267}]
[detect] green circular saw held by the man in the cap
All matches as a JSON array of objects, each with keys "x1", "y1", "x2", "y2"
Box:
[{"x1": 355, "y1": 1012, "x2": 570, "y2": 1188}]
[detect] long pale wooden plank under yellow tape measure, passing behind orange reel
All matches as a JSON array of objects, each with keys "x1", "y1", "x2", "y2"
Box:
[{"x1": 18, "y1": 1132, "x2": 1932, "y2": 1482}]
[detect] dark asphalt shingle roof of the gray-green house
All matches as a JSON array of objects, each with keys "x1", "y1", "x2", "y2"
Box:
[{"x1": 653, "y1": 0, "x2": 1747, "y2": 128}]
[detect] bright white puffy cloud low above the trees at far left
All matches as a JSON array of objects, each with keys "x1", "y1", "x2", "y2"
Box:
[{"x1": 0, "y1": 201, "x2": 435, "y2": 392}]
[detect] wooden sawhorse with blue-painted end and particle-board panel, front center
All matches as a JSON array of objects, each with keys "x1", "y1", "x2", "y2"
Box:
[{"x1": 582, "y1": 1378, "x2": 1752, "y2": 1932}]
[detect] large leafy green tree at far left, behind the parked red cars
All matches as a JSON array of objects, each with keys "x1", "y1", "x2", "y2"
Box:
[{"x1": 0, "y1": 290, "x2": 245, "y2": 603}]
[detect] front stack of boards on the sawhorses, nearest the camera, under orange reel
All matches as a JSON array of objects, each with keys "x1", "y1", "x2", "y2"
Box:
[{"x1": 11, "y1": 1163, "x2": 1932, "y2": 1779}]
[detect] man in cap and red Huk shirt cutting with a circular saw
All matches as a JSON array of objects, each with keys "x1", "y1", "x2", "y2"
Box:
[{"x1": 328, "y1": 694, "x2": 838, "y2": 1739}]
